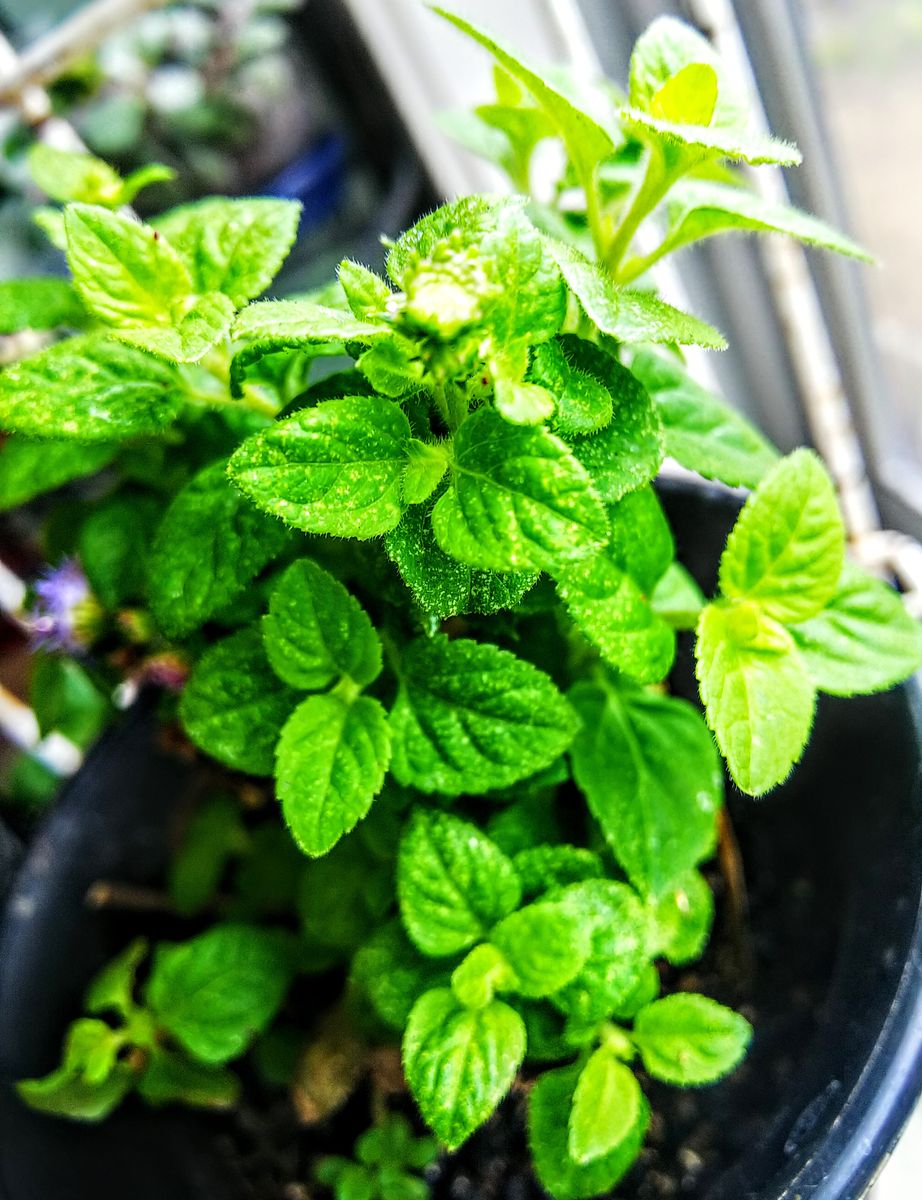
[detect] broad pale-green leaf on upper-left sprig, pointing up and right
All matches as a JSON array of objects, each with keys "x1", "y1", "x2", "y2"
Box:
[{"x1": 154, "y1": 197, "x2": 301, "y2": 308}]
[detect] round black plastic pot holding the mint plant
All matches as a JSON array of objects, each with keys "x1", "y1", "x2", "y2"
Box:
[{"x1": 0, "y1": 484, "x2": 922, "y2": 1200}]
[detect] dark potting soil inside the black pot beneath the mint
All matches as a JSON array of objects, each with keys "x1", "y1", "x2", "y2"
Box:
[{"x1": 204, "y1": 777, "x2": 836, "y2": 1200}]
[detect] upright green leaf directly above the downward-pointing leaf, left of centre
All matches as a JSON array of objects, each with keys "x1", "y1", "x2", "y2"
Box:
[{"x1": 263, "y1": 558, "x2": 381, "y2": 691}]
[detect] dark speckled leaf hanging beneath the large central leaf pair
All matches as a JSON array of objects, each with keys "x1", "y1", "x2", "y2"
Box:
[{"x1": 384, "y1": 496, "x2": 538, "y2": 617}]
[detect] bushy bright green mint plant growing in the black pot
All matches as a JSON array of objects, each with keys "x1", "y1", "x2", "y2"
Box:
[{"x1": 0, "y1": 14, "x2": 920, "y2": 1200}]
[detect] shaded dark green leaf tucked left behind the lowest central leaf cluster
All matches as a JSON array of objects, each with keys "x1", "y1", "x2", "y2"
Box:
[{"x1": 351, "y1": 920, "x2": 450, "y2": 1033}]
